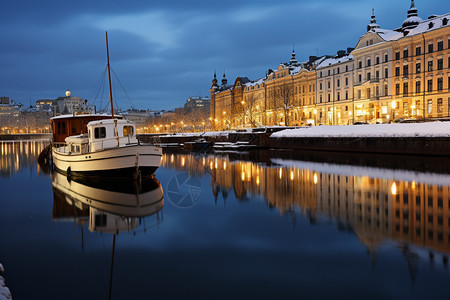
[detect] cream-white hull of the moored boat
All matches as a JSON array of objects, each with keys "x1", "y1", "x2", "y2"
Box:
[{"x1": 52, "y1": 145, "x2": 162, "y2": 177}]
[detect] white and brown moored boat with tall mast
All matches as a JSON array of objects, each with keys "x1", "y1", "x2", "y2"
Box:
[{"x1": 51, "y1": 33, "x2": 162, "y2": 178}]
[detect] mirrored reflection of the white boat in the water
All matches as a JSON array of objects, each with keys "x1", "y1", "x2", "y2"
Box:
[{"x1": 52, "y1": 172, "x2": 164, "y2": 233}]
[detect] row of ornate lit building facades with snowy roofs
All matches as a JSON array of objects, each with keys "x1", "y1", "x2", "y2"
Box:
[{"x1": 210, "y1": 0, "x2": 450, "y2": 130}]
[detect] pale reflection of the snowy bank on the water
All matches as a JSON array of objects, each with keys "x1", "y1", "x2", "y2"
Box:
[{"x1": 271, "y1": 158, "x2": 450, "y2": 186}]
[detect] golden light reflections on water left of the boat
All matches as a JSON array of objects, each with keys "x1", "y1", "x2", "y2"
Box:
[{"x1": 0, "y1": 140, "x2": 49, "y2": 178}]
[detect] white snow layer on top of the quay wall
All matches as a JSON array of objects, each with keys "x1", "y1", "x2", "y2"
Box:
[{"x1": 271, "y1": 122, "x2": 450, "y2": 138}]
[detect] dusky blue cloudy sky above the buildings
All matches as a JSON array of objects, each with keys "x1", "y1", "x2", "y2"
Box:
[{"x1": 0, "y1": 0, "x2": 450, "y2": 110}]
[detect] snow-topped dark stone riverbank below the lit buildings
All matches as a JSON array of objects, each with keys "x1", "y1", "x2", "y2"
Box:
[{"x1": 139, "y1": 122, "x2": 450, "y2": 156}]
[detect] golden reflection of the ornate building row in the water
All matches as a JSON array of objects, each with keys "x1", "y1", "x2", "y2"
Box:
[{"x1": 163, "y1": 154, "x2": 450, "y2": 276}]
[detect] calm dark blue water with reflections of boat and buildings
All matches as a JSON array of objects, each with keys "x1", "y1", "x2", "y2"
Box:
[{"x1": 0, "y1": 142, "x2": 450, "y2": 299}]
